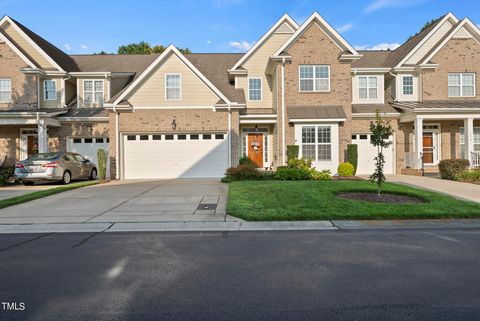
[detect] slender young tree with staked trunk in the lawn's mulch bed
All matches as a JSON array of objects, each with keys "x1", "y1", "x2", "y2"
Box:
[{"x1": 369, "y1": 111, "x2": 393, "y2": 196}]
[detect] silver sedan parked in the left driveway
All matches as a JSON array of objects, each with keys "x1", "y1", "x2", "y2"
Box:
[{"x1": 14, "y1": 153, "x2": 97, "y2": 185}]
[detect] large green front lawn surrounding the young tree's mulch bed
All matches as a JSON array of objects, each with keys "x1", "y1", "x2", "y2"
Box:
[{"x1": 227, "y1": 181, "x2": 480, "y2": 221}]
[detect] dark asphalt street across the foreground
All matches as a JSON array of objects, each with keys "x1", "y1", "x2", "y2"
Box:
[{"x1": 0, "y1": 229, "x2": 480, "y2": 321}]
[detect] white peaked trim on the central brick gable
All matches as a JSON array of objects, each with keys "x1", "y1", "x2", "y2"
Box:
[{"x1": 274, "y1": 12, "x2": 359, "y2": 56}]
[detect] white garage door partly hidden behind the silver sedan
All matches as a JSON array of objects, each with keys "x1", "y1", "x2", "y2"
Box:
[{"x1": 67, "y1": 137, "x2": 110, "y2": 177}]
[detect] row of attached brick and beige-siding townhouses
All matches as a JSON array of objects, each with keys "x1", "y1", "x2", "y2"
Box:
[{"x1": 0, "y1": 13, "x2": 480, "y2": 179}]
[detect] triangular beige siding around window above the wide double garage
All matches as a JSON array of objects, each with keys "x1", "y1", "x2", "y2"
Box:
[{"x1": 128, "y1": 54, "x2": 219, "y2": 107}]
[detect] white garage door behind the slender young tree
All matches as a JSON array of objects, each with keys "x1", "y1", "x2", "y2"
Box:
[{"x1": 352, "y1": 134, "x2": 395, "y2": 174}]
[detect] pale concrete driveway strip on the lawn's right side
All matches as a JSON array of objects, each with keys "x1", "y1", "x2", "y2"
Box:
[{"x1": 387, "y1": 175, "x2": 480, "y2": 203}]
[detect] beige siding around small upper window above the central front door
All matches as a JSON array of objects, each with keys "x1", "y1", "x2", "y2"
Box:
[{"x1": 236, "y1": 33, "x2": 291, "y2": 108}]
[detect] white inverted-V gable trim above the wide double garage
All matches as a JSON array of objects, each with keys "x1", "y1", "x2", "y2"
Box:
[{"x1": 113, "y1": 45, "x2": 231, "y2": 105}]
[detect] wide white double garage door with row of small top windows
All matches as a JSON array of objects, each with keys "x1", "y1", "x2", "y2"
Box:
[{"x1": 123, "y1": 133, "x2": 228, "y2": 179}]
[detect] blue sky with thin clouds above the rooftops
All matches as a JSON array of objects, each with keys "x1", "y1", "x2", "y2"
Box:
[{"x1": 0, "y1": 0, "x2": 480, "y2": 54}]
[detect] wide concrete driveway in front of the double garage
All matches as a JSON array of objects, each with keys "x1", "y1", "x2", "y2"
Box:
[{"x1": 0, "y1": 179, "x2": 236, "y2": 224}]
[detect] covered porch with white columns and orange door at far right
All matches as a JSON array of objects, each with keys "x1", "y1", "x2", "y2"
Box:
[{"x1": 394, "y1": 101, "x2": 480, "y2": 172}]
